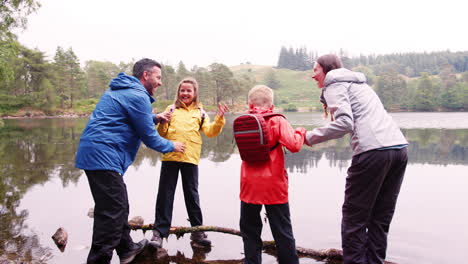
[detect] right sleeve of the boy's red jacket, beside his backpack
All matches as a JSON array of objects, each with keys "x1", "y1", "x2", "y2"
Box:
[{"x1": 272, "y1": 117, "x2": 306, "y2": 152}]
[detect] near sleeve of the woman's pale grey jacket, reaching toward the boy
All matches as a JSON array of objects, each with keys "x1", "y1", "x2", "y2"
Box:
[{"x1": 306, "y1": 83, "x2": 354, "y2": 146}]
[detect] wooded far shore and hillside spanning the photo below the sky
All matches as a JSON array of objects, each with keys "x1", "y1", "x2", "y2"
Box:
[{"x1": 0, "y1": 0, "x2": 468, "y2": 116}]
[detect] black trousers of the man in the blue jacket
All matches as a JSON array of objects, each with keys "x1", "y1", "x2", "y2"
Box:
[{"x1": 85, "y1": 170, "x2": 134, "y2": 264}]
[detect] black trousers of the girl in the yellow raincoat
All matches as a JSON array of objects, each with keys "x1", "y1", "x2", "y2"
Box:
[{"x1": 154, "y1": 161, "x2": 203, "y2": 237}]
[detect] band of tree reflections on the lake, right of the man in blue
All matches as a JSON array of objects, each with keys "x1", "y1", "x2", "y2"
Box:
[{"x1": 104, "y1": 117, "x2": 468, "y2": 173}]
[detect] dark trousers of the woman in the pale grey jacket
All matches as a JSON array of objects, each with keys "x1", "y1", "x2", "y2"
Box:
[{"x1": 341, "y1": 148, "x2": 408, "y2": 264}]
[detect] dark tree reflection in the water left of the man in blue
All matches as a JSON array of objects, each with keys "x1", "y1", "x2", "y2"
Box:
[{"x1": 0, "y1": 119, "x2": 84, "y2": 263}]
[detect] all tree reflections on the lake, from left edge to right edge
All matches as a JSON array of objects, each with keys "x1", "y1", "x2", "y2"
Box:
[{"x1": 0, "y1": 114, "x2": 468, "y2": 263}]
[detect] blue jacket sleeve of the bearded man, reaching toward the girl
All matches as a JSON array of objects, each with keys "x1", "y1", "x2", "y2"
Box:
[{"x1": 127, "y1": 96, "x2": 174, "y2": 153}]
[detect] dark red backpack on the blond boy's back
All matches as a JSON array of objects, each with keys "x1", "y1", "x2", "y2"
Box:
[{"x1": 233, "y1": 113, "x2": 286, "y2": 162}]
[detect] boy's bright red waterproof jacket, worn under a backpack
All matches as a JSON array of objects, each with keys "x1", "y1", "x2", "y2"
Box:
[{"x1": 240, "y1": 109, "x2": 306, "y2": 204}]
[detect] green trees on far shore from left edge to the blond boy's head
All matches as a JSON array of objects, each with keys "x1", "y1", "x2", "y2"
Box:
[{"x1": 0, "y1": 42, "x2": 255, "y2": 113}]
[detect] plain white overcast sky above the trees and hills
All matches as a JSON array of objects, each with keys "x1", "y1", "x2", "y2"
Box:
[{"x1": 18, "y1": 0, "x2": 468, "y2": 68}]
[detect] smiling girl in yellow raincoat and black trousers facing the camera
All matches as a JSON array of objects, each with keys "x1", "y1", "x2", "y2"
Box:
[{"x1": 150, "y1": 78, "x2": 227, "y2": 247}]
